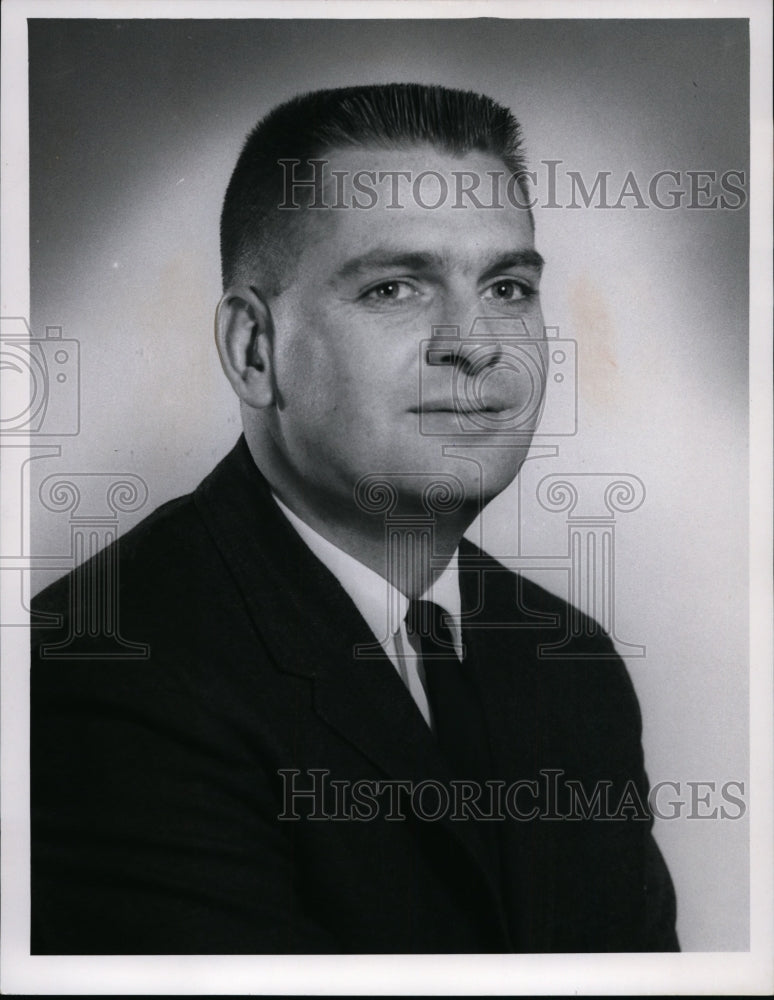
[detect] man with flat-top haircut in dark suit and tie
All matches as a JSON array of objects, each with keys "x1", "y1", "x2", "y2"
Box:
[{"x1": 32, "y1": 85, "x2": 677, "y2": 953}]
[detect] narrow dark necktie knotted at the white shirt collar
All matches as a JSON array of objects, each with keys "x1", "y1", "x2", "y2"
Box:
[{"x1": 406, "y1": 600, "x2": 492, "y2": 781}]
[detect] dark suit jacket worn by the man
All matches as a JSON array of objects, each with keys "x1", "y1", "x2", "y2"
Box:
[{"x1": 31, "y1": 440, "x2": 677, "y2": 954}]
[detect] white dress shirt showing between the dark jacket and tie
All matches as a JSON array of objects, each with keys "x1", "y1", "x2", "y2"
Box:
[{"x1": 272, "y1": 494, "x2": 462, "y2": 726}]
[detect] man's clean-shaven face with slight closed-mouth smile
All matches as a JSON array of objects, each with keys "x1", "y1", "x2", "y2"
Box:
[{"x1": 270, "y1": 146, "x2": 545, "y2": 516}]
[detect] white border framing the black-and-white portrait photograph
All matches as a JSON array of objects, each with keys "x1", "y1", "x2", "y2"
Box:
[{"x1": 0, "y1": 0, "x2": 774, "y2": 995}]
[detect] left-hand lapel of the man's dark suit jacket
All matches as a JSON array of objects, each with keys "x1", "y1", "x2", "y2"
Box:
[{"x1": 195, "y1": 438, "x2": 508, "y2": 950}]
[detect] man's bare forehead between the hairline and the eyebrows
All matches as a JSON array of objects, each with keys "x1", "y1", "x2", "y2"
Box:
[{"x1": 278, "y1": 144, "x2": 542, "y2": 280}]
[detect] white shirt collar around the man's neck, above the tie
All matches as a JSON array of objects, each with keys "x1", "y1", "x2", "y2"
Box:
[{"x1": 272, "y1": 493, "x2": 462, "y2": 651}]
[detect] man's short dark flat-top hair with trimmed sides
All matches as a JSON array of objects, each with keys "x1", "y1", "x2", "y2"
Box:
[{"x1": 220, "y1": 83, "x2": 531, "y2": 293}]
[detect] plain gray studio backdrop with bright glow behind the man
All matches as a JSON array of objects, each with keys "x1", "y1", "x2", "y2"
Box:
[{"x1": 25, "y1": 19, "x2": 752, "y2": 950}]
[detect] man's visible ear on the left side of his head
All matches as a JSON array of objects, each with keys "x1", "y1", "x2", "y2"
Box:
[{"x1": 215, "y1": 286, "x2": 275, "y2": 409}]
